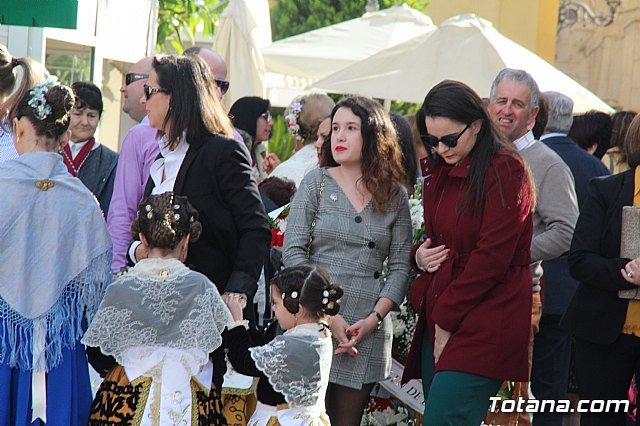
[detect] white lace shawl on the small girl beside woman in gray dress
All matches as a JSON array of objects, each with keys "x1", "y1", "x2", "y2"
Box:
[{"x1": 249, "y1": 324, "x2": 333, "y2": 409}]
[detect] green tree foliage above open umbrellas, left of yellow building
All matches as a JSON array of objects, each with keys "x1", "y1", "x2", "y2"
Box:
[{"x1": 271, "y1": 0, "x2": 431, "y2": 41}]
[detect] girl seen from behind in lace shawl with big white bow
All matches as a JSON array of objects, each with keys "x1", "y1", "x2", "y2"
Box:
[{"x1": 82, "y1": 192, "x2": 233, "y2": 425}]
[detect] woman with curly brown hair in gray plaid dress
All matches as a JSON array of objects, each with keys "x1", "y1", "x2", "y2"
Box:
[{"x1": 283, "y1": 97, "x2": 411, "y2": 426}]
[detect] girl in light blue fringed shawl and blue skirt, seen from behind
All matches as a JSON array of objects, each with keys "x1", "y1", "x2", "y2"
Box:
[{"x1": 0, "y1": 77, "x2": 111, "y2": 426}]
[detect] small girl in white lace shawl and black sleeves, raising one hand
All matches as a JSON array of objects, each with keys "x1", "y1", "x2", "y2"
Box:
[{"x1": 225, "y1": 265, "x2": 343, "y2": 426}]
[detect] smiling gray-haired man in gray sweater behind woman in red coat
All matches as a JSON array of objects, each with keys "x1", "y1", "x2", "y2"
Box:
[{"x1": 488, "y1": 68, "x2": 578, "y2": 426}]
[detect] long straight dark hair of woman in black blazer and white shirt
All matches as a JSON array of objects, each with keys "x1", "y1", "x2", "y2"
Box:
[{"x1": 152, "y1": 55, "x2": 233, "y2": 149}]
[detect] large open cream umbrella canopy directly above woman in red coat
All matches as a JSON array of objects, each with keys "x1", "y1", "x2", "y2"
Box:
[{"x1": 312, "y1": 14, "x2": 613, "y2": 113}]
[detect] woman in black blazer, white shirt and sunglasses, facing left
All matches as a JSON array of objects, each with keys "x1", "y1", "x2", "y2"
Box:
[{"x1": 136, "y1": 56, "x2": 271, "y2": 306}]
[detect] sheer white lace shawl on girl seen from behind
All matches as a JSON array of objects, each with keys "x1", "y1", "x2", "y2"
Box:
[{"x1": 82, "y1": 259, "x2": 233, "y2": 366}]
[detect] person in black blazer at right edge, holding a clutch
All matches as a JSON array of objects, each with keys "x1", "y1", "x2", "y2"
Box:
[{"x1": 561, "y1": 117, "x2": 640, "y2": 426}]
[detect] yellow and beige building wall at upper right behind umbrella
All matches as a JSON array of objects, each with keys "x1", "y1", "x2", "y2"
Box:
[{"x1": 426, "y1": 0, "x2": 640, "y2": 111}]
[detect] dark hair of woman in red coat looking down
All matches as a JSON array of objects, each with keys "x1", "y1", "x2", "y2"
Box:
[{"x1": 416, "y1": 80, "x2": 535, "y2": 214}]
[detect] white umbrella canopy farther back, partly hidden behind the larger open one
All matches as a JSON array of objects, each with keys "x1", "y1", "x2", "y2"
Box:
[{"x1": 262, "y1": 4, "x2": 436, "y2": 103}]
